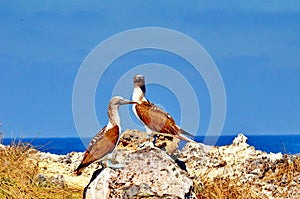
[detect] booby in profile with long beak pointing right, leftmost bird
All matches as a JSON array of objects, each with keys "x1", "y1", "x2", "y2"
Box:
[{"x1": 74, "y1": 96, "x2": 134, "y2": 175}]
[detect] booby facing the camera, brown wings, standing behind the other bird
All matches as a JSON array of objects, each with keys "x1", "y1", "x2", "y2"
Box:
[{"x1": 132, "y1": 75, "x2": 193, "y2": 144}]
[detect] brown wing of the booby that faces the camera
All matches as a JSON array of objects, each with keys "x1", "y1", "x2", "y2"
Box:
[{"x1": 135, "y1": 102, "x2": 180, "y2": 136}]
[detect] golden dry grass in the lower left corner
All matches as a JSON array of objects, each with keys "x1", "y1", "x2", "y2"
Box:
[{"x1": 0, "y1": 142, "x2": 82, "y2": 199}]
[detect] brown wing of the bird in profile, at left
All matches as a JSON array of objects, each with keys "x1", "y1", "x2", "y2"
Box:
[{"x1": 75, "y1": 125, "x2": 119, "y2": 175}]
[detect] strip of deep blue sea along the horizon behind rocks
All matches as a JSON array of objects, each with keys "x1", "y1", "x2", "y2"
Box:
[{"x1": 2, "y1": 135, "x2": 300, "y2": 155}]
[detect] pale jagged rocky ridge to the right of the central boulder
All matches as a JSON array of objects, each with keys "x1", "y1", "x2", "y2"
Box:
[{"x1": 180, "y1": 134, "x2": 300, "y2": 198}]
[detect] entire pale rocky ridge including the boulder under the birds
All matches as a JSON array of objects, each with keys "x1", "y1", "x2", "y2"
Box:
[{"x1": 18, "y1": 130, "x2": 300, "y2": 199}]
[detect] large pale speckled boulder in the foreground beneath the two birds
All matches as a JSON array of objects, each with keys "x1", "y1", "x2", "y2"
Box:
[{"x1": 86, "y1": 146, "x2": 193, "y2": 199}]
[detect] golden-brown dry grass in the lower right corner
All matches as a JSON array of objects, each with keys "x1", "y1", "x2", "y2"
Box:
[{"x1": 194, "y1": 155, "x2": 300, "y2": 199}]
